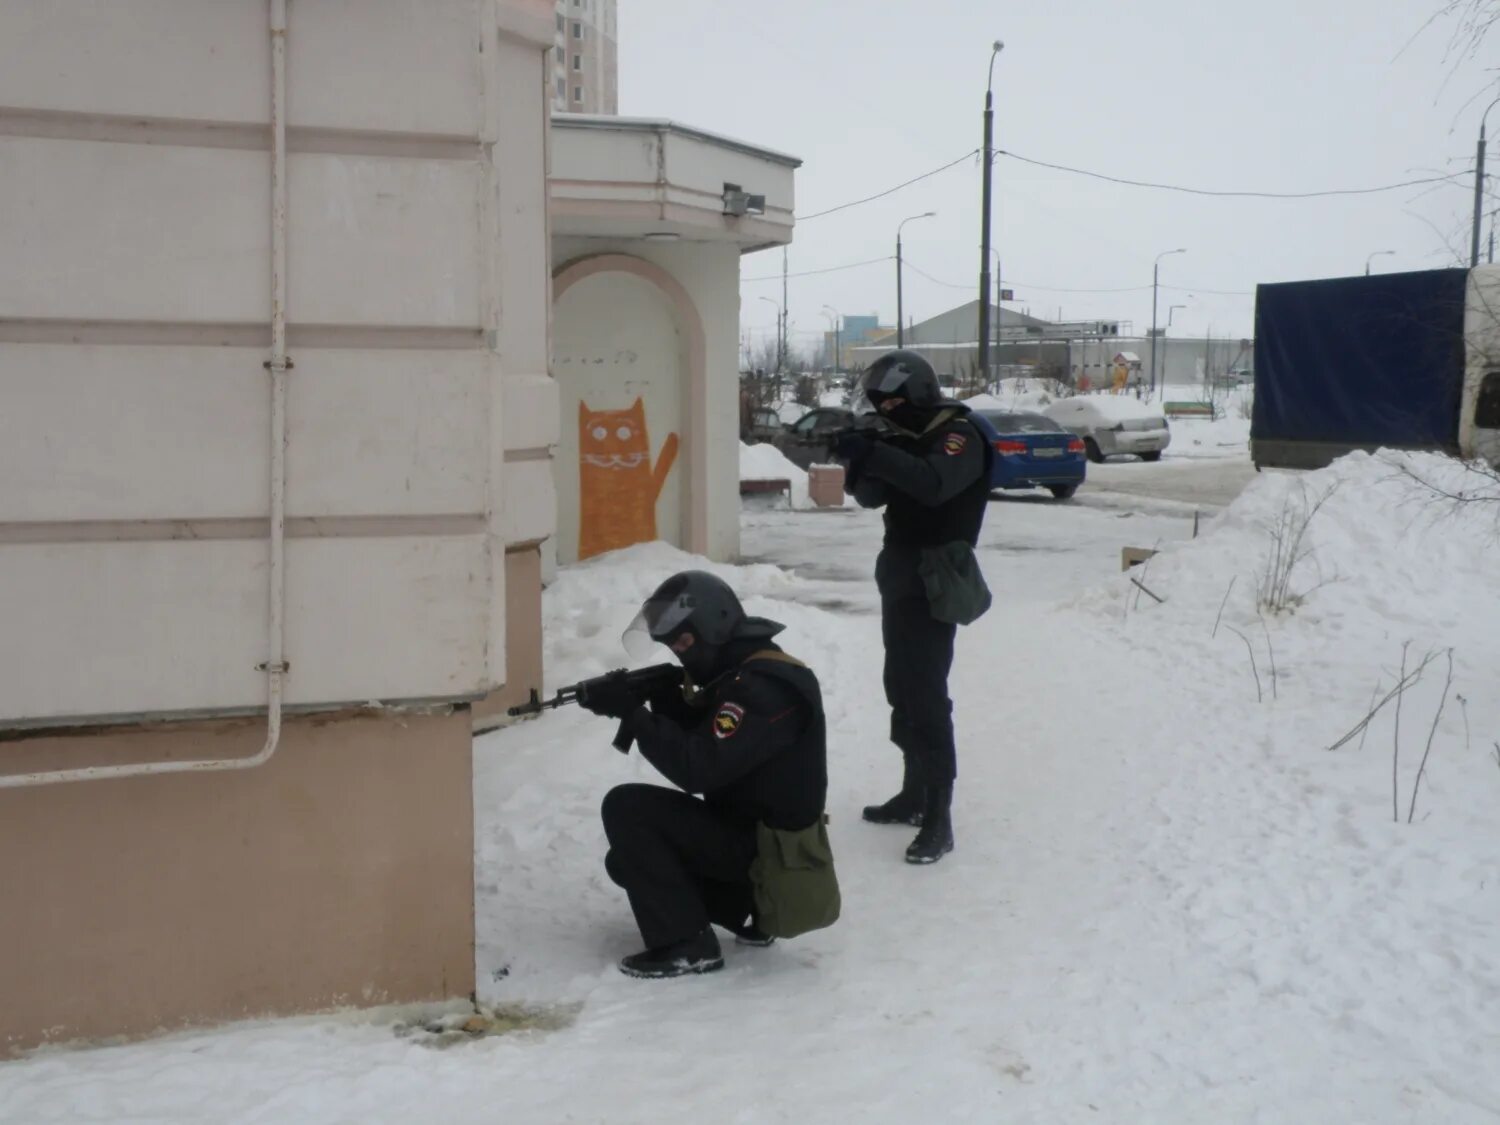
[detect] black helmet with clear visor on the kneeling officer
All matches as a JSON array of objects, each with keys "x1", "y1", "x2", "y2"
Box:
[{"x1": 624, "y1": 570, "x2": 785, "y2": 684}]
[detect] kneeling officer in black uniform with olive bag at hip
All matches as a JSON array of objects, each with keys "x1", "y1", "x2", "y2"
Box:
[{"x1": 584, "y1": 570, "x2": 839, "y2": 977}]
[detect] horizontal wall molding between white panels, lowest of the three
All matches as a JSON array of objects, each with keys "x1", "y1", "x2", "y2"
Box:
[{"x1": 0, "y1": 515, "x2": 489, "y2": 546}]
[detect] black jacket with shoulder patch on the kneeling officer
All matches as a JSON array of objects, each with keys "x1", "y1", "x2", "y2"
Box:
[{"x1": 627, "y1": 642, "x2": 828, "y2": 830}]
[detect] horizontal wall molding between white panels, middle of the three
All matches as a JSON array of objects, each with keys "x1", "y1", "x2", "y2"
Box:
[{"x1": 0, "y1": 317, "x2": 488, "y2": 351}]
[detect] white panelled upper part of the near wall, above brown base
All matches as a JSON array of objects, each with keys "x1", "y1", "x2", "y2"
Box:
[{"x1": 0, "y1": 0, "x2": 555, "y2": 723}]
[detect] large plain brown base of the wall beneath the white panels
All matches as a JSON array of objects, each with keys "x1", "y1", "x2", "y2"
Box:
[{"x1": 0, "y1": 710, "x2": 474, "y2": 1056}]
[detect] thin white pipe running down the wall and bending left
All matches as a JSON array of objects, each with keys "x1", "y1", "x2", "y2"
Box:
[{"x1": 0, "y1": 0, "x2": 291, "y2": 789}]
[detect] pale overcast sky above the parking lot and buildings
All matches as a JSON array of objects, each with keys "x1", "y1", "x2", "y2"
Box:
[{"x1": 620, "y1": 0, "x2": 1500, "y2": 354}]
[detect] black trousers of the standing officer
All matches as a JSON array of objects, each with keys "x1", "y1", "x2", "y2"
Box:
[{"x1": 881, "y1": 594, "x2": 959, "y2": 785}]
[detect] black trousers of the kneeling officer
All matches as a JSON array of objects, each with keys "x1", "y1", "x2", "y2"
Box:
[{"x1": 602, "y1": 785, "x2": 756, "y2": 950}]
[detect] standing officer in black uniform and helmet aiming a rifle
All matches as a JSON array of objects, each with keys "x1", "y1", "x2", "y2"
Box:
[{"x1": 834, "y1": 351, "x2": 992, "y2": 864}]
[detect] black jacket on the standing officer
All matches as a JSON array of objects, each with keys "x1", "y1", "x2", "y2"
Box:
[{"x1": 846, "y1": 407, "x2": 990, "y2": 593}]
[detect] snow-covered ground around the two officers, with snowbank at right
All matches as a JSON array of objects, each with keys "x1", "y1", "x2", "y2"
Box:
[{"x1": 0, "y1": 453, "x2": 1500, "y2": 1122}]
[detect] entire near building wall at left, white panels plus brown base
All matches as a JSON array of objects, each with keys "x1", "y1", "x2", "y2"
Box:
[{"x1": 0, "y1": 0, "x2": 557, "y2": 1052}]
